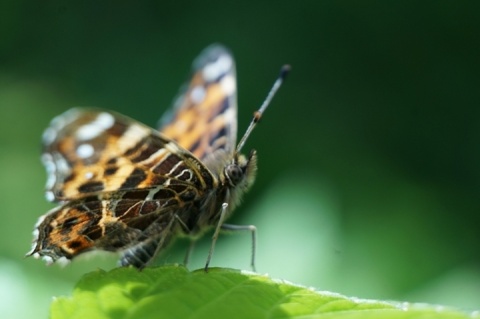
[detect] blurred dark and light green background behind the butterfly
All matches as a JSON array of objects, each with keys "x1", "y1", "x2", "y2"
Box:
[{"x1": 0, "y1": 0, "x2": 480, "y2": 318}]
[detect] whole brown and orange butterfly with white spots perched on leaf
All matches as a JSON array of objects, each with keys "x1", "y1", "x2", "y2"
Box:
[{"x1": 27, "y1": 44, "x2": 288, "y2": 269}]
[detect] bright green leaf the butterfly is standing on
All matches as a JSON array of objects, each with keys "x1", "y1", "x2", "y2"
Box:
[{"x1": 51, "y1": 266, "x2": 480, "y2": 319}]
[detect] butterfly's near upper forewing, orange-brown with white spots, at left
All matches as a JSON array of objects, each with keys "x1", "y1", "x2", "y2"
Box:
[{"x1": 42, "y1": 109, "x2": 216, "y2": 201}]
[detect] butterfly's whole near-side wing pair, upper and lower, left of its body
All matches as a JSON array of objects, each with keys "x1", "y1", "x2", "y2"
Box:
[{"x1": 27, "y1": 109, "x2": 218, "y2": 268}]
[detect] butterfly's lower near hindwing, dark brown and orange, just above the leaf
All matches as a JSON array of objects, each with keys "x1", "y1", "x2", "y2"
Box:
[{"x1": 27, "y1": 191, "x2": 191, "y2": 268}]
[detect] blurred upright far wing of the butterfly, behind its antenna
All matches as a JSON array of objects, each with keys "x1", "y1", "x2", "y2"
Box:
[{"x1": 159, "y1": 45, "x2": 237, "y2": 165}]
